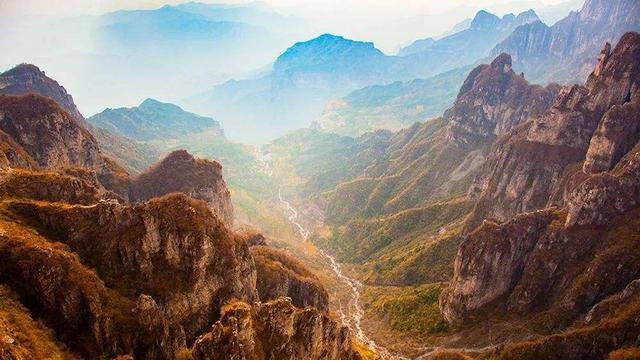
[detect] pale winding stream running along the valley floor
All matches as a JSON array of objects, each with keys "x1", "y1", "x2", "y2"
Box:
[{"x1": 278, "y1": 186, "x2": 406, "y2": 359}]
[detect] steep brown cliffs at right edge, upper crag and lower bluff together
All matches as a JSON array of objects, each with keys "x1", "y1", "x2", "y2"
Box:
[{"x1": 441, "y1": 33, "x2": 640, "y2": 332}]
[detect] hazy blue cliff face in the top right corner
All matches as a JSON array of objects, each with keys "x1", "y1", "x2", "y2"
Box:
[{"x1": 491, "y1": 0, "x2": 640, "y2": 83}]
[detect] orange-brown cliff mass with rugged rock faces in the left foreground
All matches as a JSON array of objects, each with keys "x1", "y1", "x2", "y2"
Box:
[{"x1": 0, "y1": 169, "x2": 355, "y2": 359}]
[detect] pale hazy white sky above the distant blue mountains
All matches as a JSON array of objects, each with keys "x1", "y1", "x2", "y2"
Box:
[{"x1": 0, "y1": 0, "x2": 577, "y2": 52}]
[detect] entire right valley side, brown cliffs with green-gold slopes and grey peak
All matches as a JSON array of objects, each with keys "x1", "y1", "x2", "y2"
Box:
[{"x1": 266, "y1": 26, "x2": 640, "y2": 359}]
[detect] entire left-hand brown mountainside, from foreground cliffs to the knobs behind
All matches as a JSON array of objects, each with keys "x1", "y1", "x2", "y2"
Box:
[{"x1": 0, "y1": 61, "x2": 361, "y2": 359}]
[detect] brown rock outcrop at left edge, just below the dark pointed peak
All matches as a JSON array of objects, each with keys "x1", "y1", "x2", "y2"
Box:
[{"x1": 0, "y1": 94, "x2": 103, "y2": 170}]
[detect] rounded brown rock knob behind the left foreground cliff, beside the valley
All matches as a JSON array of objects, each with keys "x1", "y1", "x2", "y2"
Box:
[{"x1": 129, "y1": 150, "x2": 233, "y2": 226}]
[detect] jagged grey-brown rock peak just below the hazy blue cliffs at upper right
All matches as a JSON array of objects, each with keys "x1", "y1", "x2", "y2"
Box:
[{"x1": 444, "y1": 53, "x2": 559, "y2": 147}]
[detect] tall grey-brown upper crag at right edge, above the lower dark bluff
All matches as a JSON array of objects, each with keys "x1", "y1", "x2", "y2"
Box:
[{"x1": 466, "y1": 33, "x2": 640, "y2": 231}]
